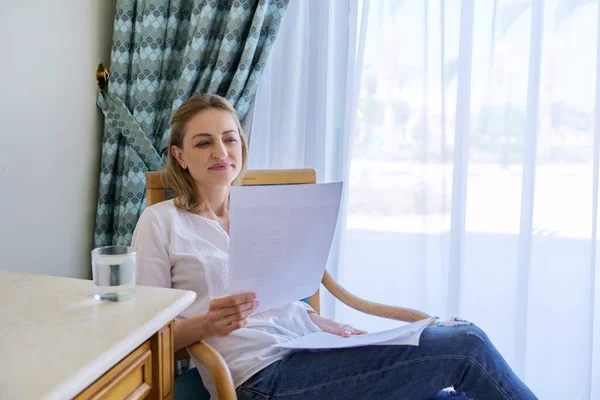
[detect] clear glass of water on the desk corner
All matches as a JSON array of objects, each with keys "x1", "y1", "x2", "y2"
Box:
[{"x1": 92, "y1": 246, "x2": 137, "y2": 301}]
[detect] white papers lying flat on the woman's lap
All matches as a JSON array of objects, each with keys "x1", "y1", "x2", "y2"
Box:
[{"x1": 274, "y1": 317, "x2": 435, "y2": 350}]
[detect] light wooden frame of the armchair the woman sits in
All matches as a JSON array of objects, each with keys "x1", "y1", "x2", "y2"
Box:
[{"x1": 146, "y1": 169, "x2": 429, "y2": 400}]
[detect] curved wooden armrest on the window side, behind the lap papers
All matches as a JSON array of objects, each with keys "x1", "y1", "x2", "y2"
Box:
[{"x1": 321, "y1": 271, "x2": 429, "y2": 322}]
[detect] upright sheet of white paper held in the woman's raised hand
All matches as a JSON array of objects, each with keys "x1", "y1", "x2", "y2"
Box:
[{"x1": 208, "y1": 182, "x2": 342, "y2": 312}]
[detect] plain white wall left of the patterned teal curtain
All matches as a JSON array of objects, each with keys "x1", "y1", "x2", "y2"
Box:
[{"x1": 0, "y1": 0, "x2": 116, "y2": 278}]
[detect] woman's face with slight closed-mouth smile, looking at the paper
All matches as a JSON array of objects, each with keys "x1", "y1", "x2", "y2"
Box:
[{"x1": 171, "y1": 108, "x2": 242, "y2": 186}]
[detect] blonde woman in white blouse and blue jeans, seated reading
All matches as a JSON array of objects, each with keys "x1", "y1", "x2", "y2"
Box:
[{"x1": 132, "y1": 95, "x2": 535, "y2": 400}]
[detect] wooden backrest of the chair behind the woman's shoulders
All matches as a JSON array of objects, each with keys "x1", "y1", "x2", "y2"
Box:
[{"x1": 146, "y1": 169, "x2": 321, "y2": 312}]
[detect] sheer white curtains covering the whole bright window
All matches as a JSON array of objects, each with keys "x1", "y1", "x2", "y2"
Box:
[{"x1": 250, "y1": 0, "x2": 600, "y2": 399}]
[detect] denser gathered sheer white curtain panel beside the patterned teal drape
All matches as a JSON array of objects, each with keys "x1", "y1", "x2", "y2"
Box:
[{"x1": 249, "y1": 0, "x2": 369, "y2": 317}]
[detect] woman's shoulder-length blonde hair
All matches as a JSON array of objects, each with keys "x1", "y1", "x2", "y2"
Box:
[{"x1": 164, "y1": 94, "x2": 248, "y2": 213}]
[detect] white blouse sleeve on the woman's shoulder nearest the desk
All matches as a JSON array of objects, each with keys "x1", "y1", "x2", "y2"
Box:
[{"x1": 131, "y1": 207, "x2": 171, "y2": 288}]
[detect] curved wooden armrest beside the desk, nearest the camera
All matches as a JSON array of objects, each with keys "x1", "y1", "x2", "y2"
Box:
[{"x1": 188, "y1": 341, "x2": 237, "y2": 400}]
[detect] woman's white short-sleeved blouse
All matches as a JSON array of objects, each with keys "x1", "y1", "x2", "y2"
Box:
[{"x1": 131, "y1": 200, "x2": 320, "y2": 399}]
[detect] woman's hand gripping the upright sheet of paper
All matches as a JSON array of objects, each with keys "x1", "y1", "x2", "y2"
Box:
[{"x1": 206, "y1": 293, "x2": 258, "y2": 336}]
